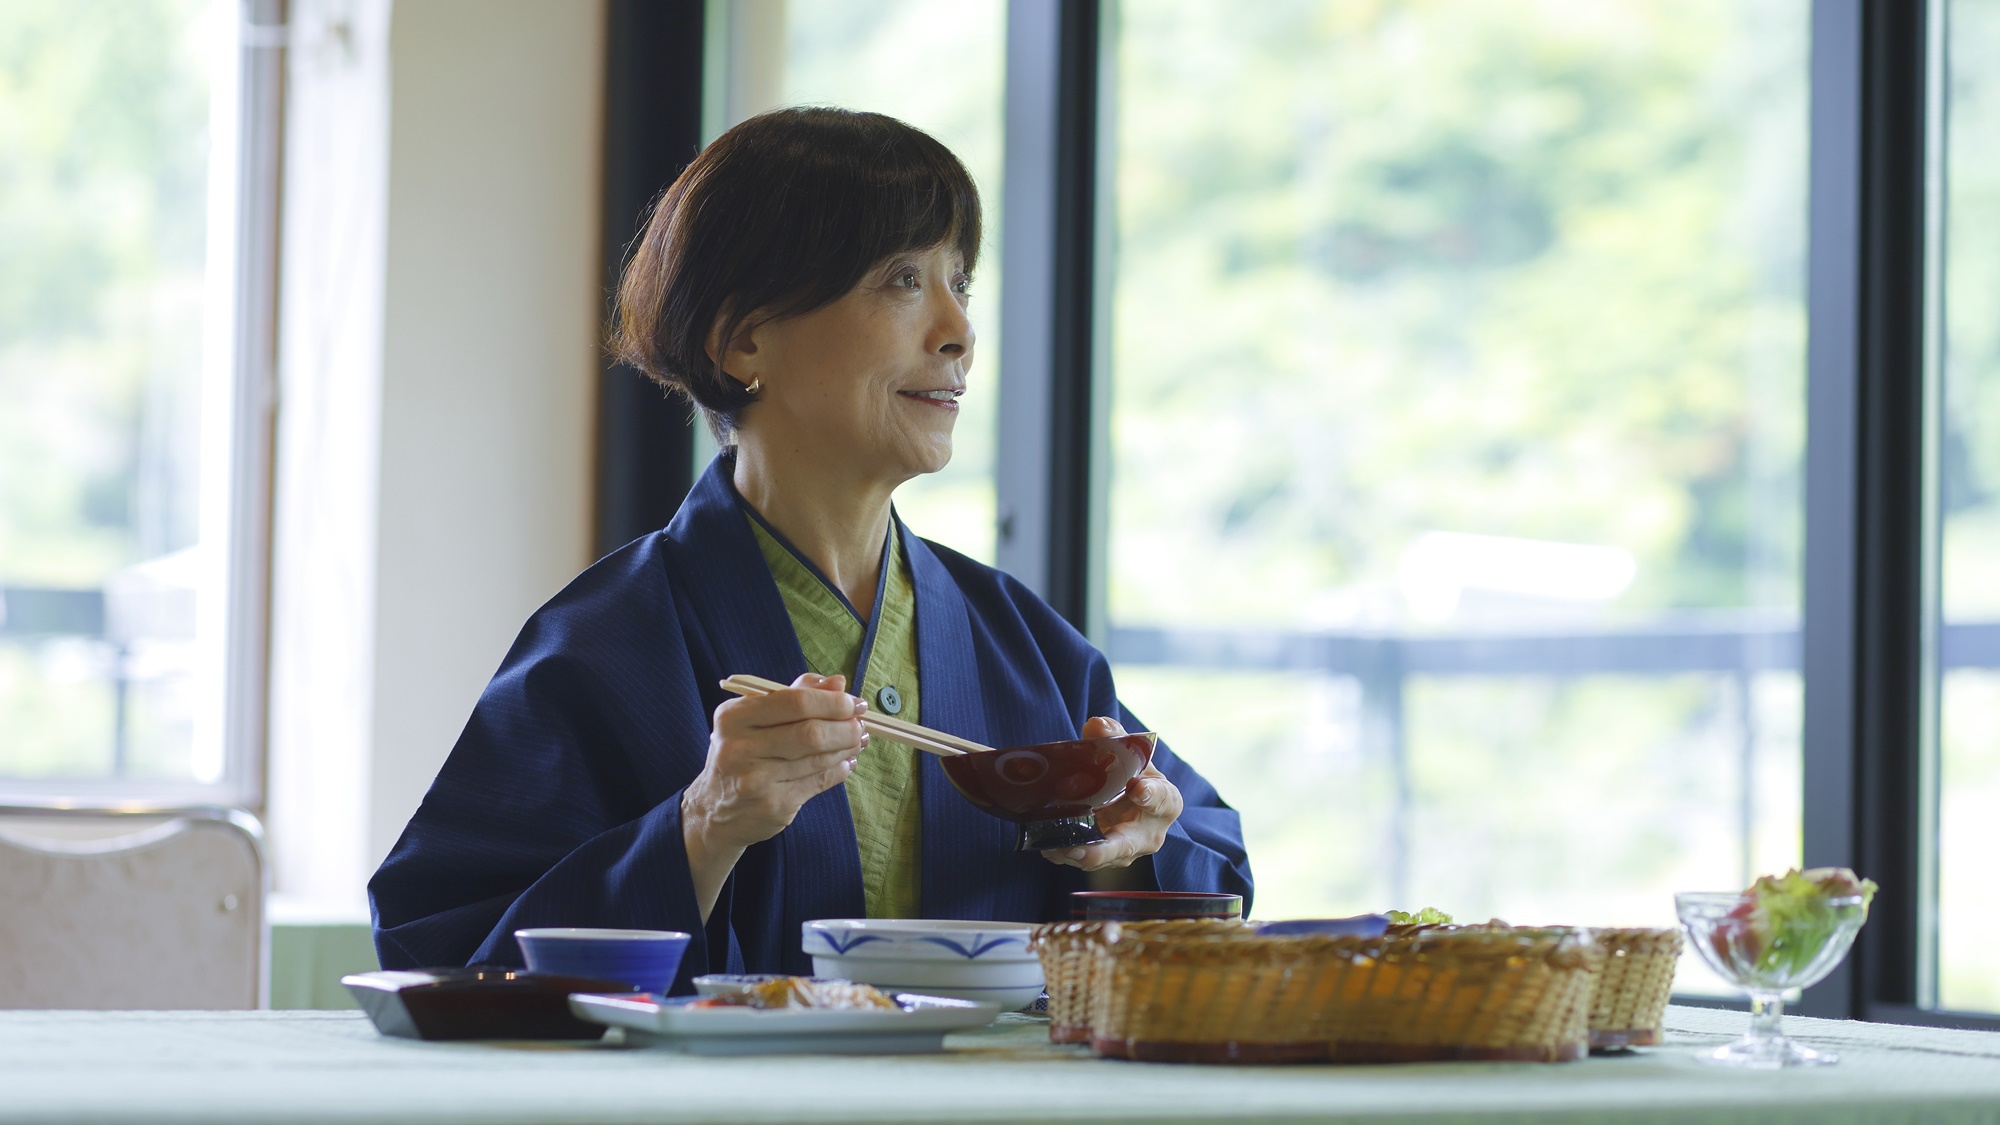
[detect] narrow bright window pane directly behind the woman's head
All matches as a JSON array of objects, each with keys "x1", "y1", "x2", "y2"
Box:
[{"x1": 706, "y1": 0, "x2": 1006, "y2": 563}]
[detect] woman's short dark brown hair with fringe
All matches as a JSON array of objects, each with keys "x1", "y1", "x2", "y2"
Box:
[{"x1": 612, "y1": 108, "x2": 980, "y2": 440}]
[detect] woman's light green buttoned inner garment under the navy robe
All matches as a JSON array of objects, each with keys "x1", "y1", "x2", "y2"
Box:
[{"x1": 744, "y1": 514, "x2": 924, "y2": 919}]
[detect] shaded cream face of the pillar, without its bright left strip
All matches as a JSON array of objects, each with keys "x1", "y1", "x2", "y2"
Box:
[{"x1": 368, "y1": 0, "x2": 604, "y2": 867}]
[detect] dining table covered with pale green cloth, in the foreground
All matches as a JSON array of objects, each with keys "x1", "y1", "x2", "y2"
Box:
[{"x1": 0, "y1": 1007, "x2": 2000, "y2": 1125}]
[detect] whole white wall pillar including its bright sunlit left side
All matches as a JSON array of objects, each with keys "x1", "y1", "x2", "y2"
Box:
[{"x1": 270, "y1": 0, "x2": 604, "y2": 903}]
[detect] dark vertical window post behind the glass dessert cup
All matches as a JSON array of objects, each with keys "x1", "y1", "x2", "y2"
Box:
[{"x1": 1802, "y1": 0, "x2": 1926, "y2": 1017}]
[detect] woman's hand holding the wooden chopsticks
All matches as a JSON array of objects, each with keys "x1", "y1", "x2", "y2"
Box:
[{"x1": 680, "y1": 673, "x2": 868, "y2": 921}]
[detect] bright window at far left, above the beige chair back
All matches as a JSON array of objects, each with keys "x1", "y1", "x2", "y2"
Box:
[{"x1": 0, "y1": 0, "x2": 276, "y2": 803}]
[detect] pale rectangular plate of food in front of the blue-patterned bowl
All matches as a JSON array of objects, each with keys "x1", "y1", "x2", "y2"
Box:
[{"x1": 570, "y1": 993, "x2": 1000, "y2": 1055}]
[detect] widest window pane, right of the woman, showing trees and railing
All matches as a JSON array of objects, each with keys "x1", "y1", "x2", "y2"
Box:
[{"x1": 1098, "y1": 0, "x2": 1808, "y2": 987}]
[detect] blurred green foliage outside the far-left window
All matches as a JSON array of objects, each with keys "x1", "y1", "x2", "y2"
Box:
[{"x1": 0, "y1": 0, "x2": 220, "y2": 777}]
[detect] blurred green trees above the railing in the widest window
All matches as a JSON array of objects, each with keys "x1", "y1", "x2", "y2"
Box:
[{"x1": 1112, "y1": 0, "x2": 1806, "y2": 621}]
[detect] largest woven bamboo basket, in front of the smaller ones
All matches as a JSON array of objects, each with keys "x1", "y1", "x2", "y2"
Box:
[{"x1": 1090, "y1": 927, "x2": 1602, "y2": 1063}]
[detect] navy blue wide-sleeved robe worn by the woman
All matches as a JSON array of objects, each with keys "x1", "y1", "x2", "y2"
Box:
[{"x1": 368, "y1": 456, "x2": 1250, "y2": 993}]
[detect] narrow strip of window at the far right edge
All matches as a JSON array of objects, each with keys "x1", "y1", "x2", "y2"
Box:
[{"x1": 1932, "y1": 0, "x2": 2000, "y2": 1011}]
